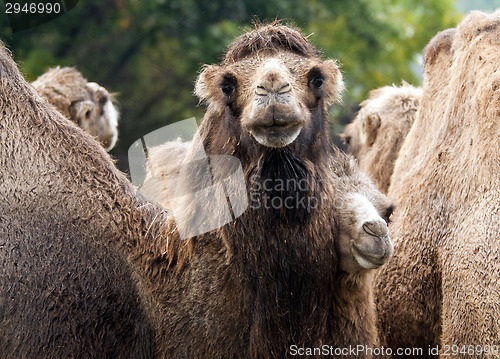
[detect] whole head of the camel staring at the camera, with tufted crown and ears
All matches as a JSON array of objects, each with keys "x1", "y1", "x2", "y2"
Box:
[{"x1": 195, "y1": 26, "x2": 343, "y2": 148}]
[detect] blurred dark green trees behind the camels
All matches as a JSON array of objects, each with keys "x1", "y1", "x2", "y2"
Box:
[{"x1": 0, "y1": 0, "x2": 488, "y2": 171}]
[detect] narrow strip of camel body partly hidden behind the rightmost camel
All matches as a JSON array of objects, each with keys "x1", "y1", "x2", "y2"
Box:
[{"x1": 375, "y1": 29, "x2": 456, "y2": 358}]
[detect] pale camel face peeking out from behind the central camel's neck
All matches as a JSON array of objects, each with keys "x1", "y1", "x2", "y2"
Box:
[{"x1": 338, "y1": 191, "x2": 394, "y2": 273}]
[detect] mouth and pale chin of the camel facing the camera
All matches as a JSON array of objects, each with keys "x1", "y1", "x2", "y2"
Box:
[{"x1": 250, "y1": 122, "x2": 302, "y2": 148}]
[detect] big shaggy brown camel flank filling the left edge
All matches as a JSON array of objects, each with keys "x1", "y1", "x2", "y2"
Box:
[{"x1": 0, "y1": 45, "x2": 166, "y2": 358}]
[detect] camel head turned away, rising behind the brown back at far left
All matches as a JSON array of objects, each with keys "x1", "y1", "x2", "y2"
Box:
[{"x1": 32, "y1": 67, "x2": 118, "y2": 151}]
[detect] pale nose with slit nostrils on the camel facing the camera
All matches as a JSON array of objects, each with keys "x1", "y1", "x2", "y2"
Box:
[{"x1": 255, "y1": 59, "x2": 292, "y2": 96}]
